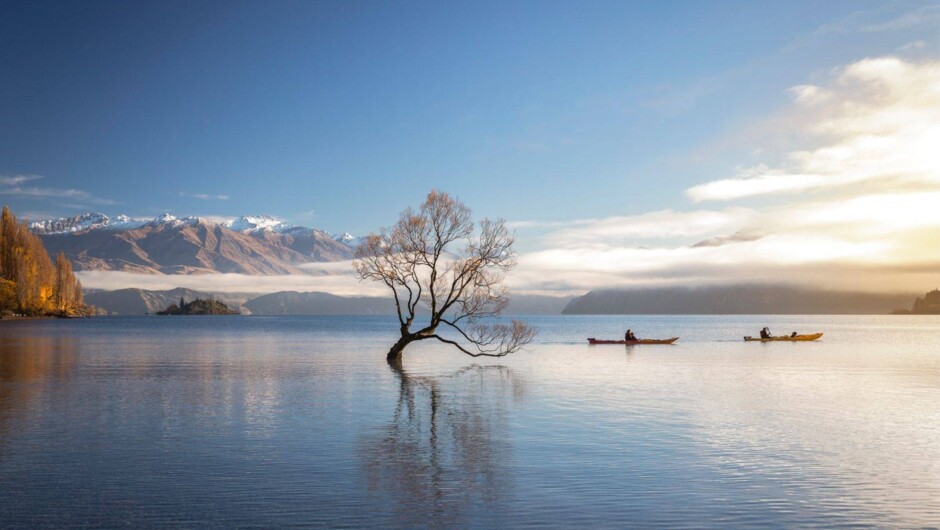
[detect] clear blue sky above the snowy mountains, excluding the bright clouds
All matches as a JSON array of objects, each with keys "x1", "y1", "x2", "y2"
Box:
[{"x1": 0, "y1": 1, "x2": 936, "y2": 233}]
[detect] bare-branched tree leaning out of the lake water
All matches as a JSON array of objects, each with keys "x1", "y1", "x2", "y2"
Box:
[{"x1": 355, "y1": 190, "x2": 535, "y2": 360}]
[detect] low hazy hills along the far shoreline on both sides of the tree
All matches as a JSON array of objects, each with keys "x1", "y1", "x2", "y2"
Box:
[{"x1": 85, "y1": 285, "x2": 916, "y2": 315}]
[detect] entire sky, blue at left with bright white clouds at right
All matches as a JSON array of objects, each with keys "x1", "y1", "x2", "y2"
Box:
[{"x1": 0, "y1": 1, "x2": 940, "y2": 293}]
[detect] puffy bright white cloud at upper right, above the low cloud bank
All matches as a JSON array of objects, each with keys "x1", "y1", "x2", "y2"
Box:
[{"x1": 686, "y1": 57, "x2": 940, "y2": 202}]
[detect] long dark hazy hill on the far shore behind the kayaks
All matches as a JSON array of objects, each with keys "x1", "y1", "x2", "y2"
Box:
[{"x1": 563, "y1": 285, "x2": 912, "y2": 315}]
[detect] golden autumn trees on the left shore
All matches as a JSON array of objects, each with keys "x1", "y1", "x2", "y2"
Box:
[{"x1": 0, "y1": 206, "x2": 86, "y2": 316}]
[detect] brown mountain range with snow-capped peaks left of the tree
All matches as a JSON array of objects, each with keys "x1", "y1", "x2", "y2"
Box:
[{"x1": 30, "y1": 213, "x2": 358, "y2": 274}]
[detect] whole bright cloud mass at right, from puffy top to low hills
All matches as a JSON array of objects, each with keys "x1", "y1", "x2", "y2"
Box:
[{"x1": 509, "y1": 57, "x2": 940, "y2": 294}]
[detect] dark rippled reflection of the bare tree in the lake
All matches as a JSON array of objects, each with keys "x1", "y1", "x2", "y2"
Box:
[{"x1": 361, "y1": 359, "x2": 524, "y2": 527}]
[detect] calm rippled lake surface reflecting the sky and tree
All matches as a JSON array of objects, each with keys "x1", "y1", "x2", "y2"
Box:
[{"x1": 0, "y1": 316, "x2": 940, "y2": 528}]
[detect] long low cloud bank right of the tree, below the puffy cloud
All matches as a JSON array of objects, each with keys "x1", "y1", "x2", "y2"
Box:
[{"x1": 509, "y1": 186, "x2": 940, "y2": 294}]
